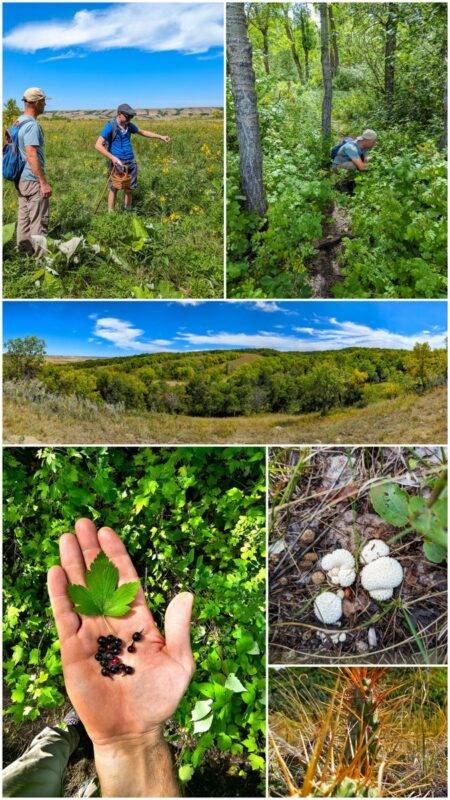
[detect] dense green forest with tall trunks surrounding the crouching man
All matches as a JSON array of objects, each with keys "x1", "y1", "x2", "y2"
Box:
[{"x1": 227, "y1": 3, "x2": 447, "y2": 298}]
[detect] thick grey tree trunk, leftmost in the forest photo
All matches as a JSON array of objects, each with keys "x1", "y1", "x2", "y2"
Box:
[{"x1": 226, "y1": 3, "x2": 267, "y2": 214}]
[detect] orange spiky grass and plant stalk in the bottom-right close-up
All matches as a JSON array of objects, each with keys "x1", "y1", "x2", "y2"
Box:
[{"x1": 269, "y1": 667, "x2": 447, "y2": 797}]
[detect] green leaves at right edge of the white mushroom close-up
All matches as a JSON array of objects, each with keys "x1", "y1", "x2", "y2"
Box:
[{"x1": 370, "y1": 472, "x2": 447, "y2": 564}]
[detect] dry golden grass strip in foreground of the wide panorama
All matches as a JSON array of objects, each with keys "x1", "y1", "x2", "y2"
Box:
[{"x1": 3, "y1": 383, "x2": 447, "y2": 444}]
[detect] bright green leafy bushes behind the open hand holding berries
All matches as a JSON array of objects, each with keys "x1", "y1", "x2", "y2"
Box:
[{"x1": 4, "y1": 447, "x2": 265, "y2": 797}]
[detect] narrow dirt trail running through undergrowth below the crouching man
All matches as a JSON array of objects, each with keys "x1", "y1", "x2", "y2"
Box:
[{"x1": 308, "y1": 202, "x2": 350, "y2": 297}]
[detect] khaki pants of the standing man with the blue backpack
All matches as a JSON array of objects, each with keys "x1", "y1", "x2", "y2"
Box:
[{"x1": 17, "y1": 181, "x2": 49, "y2": 255}]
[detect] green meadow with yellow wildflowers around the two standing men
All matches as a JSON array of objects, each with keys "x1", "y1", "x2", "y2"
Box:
[{"x1": 3, "y1": 111, "x2": 223, "y2": 298}]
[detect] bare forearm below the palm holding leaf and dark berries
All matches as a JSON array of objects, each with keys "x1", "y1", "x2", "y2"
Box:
[{"x1": 94, "y1": 730, "x2": 180, "y2": 797}]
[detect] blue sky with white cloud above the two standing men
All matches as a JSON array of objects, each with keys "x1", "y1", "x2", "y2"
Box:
[{"x1": 3, "y1": 2, "x2": 223, "y2": 110}]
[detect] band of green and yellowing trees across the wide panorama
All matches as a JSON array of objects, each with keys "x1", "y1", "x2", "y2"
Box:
[{"x1": 4, "y1": 337, "x2": 446, "y2": 417}]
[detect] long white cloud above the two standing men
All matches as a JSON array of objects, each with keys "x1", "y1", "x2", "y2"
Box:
[{"x1": 3, "y1": 3, "x2": 223, "y2": 53}]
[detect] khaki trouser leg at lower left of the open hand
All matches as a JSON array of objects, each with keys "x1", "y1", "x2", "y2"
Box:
[{"x1": 3, "y1": 725, "x2": 80, "y2": 797}]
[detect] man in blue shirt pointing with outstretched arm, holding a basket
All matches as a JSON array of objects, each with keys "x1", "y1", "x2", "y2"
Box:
[{"x1": 95, "y1": 103, "x2": 170, "y2": 211}]
